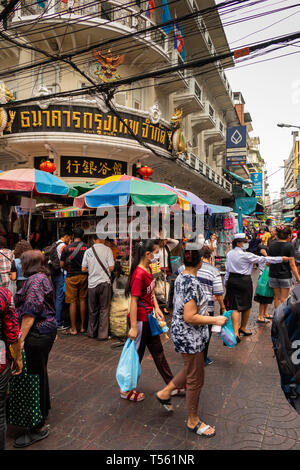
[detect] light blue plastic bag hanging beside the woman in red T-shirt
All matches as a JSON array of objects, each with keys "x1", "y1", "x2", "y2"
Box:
[{"x1": 116, "y1": 338, "x2": 141, "y2": 392}]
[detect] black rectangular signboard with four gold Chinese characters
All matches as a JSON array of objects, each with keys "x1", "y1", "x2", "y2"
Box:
[{"x1": 60, "y1": 156, "x2": 127, "y2": 179}]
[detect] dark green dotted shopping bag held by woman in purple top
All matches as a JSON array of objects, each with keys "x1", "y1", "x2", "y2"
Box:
[{"x1": 6, "y1": 350, "x2": 43, "y2": 428}]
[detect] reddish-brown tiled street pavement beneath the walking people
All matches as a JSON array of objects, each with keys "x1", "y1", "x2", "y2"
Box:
[{"x1": 7, "y1": 276, "x2": 300, "y2": 450}]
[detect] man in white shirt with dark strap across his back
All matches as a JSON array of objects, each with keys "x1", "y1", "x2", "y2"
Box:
[{"x1": 82, "y1": 235, "x2": 115, "y2": 341}]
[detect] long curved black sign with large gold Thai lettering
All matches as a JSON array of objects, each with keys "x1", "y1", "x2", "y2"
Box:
[{"x1": 4, "y1": 105, "x2": 172, "y2": 151}]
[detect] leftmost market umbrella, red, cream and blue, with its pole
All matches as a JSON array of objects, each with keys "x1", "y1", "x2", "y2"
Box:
[{"x1": 0, "y1": 168, "x2": 69, "y2": 240}]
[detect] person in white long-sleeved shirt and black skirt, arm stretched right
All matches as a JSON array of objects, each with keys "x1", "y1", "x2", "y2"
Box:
[{"x1": 224, "y1": 233, "x2": 289, "y2": 343}]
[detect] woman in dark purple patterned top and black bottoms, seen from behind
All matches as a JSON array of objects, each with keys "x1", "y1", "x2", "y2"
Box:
[{"x1": 14, "y1": 250, "x2": 57, "y2": 447}]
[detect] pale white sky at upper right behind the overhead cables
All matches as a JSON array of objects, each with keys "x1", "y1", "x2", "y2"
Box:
[{"x1": 216, "y1": 0, "x2": 300, "y2": 198}]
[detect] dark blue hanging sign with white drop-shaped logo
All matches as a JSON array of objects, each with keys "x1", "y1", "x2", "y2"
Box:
[{"x1": 226, "y1": 126, "x2": 247, "y2": 166}]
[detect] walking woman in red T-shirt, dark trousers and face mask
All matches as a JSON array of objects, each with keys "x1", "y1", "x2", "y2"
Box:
[{"x1": 121, "y1": 240, "x2": 176, "y2": 402}]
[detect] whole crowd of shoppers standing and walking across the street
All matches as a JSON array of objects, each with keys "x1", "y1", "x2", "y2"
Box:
[{"x1": 0, "y1": 226, "x2": 300, "y2": 449}]
